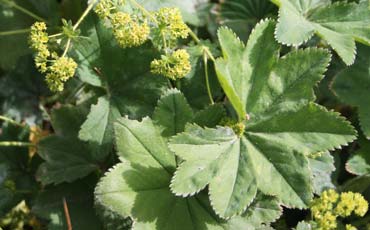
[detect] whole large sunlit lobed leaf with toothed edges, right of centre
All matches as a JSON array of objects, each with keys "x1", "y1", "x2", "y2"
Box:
[{"x1": 170, "y1": 21, "x2": 356, "y2": 218}]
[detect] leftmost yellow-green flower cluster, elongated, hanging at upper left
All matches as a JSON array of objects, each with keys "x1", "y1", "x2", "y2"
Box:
[{"x1": 30, "y1": 22, "x2": 77, "y2": 92}]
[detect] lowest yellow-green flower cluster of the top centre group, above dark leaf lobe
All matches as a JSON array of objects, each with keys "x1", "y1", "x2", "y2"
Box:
[{"x1": 150, "y1": 49, "x2": 191, "y2": 80}]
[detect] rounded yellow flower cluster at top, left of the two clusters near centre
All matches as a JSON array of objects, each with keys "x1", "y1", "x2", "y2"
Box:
[{"x1": 111, "y1": 12, "x2": 150, "y2": 48}]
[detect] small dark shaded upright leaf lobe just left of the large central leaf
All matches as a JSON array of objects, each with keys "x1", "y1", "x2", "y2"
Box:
[{"x1": 153, "y1": 89, "x2": 193, "y2": 136}]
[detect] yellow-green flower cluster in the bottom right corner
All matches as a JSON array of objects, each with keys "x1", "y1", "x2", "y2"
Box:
[{"x1": 311, "y1": 189, "x2": 368, "y2": 230}]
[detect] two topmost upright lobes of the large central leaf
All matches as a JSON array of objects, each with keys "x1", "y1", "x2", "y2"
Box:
[{"x1": 215, "y1": 21, "x2": 279, "y2": 119}]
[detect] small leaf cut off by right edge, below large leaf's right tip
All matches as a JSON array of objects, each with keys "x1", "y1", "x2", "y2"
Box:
[{"x1": 346, "y1": 140, "x2": 370, "y2": 176}]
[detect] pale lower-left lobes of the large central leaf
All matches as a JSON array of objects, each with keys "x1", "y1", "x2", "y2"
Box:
[{"x1": 170, "y1": 126, "x2": 257, "y2": 218}]
